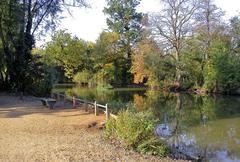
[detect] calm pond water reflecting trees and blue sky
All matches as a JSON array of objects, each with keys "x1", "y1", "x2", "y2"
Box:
[{"x1": 54, "y1": 88, "x2": 240, "y2": 162}]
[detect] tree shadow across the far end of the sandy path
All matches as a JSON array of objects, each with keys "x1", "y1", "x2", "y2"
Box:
[{"x1": 0, "y1": 95, "x2": 92, "y2": 118}]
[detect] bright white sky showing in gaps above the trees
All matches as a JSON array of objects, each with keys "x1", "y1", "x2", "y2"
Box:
[{"x1": 37, "y1": 0, "x2": 240, "y2": 46}]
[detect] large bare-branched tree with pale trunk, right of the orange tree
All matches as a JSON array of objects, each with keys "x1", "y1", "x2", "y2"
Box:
[{"x1": 151, "y1": 0, "x2": 197, "y2": 83}]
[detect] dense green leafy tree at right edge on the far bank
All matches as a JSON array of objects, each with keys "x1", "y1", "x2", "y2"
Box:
[{"x1": 204, "y1": 36, "x2": 240, "y2": 93}]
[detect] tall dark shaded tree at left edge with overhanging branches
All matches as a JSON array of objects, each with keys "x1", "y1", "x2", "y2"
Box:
[{"x1": 0, "y1": 0, "x2": 86, "y2": 91}]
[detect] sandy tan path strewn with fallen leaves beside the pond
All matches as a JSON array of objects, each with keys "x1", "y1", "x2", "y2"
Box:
[{"x1": 0, "y1": 95, "x2": 180, "y2": 162}]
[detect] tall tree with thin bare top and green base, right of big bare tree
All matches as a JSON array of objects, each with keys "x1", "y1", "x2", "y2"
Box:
[{"x1": 178, "y1": 0, "x2": 224, "y2": 89}]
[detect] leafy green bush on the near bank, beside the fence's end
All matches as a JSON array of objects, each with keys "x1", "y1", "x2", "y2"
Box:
[{"x1": 105, "y1": 109, "x2": 168, "y2": 156}]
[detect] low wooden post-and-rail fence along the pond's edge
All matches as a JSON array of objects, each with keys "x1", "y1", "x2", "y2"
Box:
[{"x1": 51, "y1": 93, "x2": 117, "y2": 120}]
